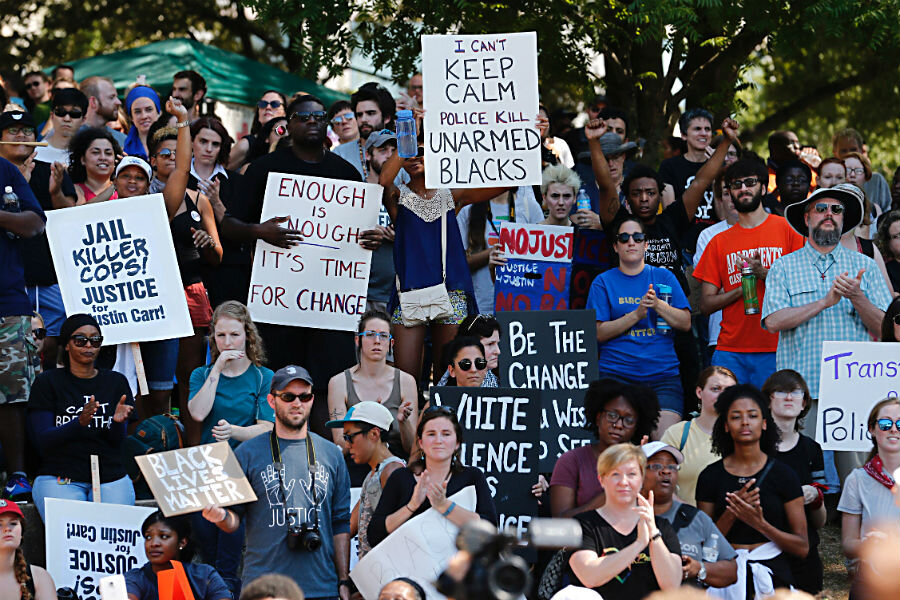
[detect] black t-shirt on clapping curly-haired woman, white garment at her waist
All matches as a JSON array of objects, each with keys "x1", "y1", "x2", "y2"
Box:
[{"x1": 696, "y1": 458, "x2": 803, "y2": 544}]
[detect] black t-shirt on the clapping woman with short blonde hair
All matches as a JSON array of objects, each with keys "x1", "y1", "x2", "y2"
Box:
[{"x1": 569, "y1": 510, "x2": 681, "y2": 600}]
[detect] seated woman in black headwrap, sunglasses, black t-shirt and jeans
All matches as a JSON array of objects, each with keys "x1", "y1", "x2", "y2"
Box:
[{"x1": 28, "y1": 313, "x2": 134, "y2": 519}]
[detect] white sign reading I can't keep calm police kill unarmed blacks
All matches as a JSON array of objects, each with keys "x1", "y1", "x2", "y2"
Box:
[{"x1": 422, "y1": 32, "x2": 541, "y2": 188}]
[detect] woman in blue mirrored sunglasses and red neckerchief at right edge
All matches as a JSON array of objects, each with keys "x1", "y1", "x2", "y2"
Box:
[{"x1": 838, "y1": 398, "x2": 900, "y2": 598}]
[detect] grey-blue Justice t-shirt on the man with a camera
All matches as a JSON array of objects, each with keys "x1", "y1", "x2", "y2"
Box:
[{"x1": 231, "y1": 433, "x2": 350, "y2": 598}]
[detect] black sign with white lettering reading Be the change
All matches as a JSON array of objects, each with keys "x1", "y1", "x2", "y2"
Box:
[{"x1": 495, "y1": 310, "x2": 599, "y2": 473}]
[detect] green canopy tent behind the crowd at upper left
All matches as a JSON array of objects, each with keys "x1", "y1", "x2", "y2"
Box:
[{"x1": 69, "y1": 38, "x2": 348, "y2": 106}]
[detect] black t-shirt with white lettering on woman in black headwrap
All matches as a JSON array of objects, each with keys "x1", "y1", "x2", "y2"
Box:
[{"x1": 28, "y1": 369, "x2": 134, "y2": 483}]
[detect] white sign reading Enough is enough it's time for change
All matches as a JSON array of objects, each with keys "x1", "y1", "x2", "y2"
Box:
[{"x1": 247, "y1": 173, "x2": 382, "y2": 331}]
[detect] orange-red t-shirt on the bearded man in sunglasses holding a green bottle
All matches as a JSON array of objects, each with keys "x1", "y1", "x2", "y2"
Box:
[{"x1": 694, "y1": 215, "x2": 806, "y2": 352}]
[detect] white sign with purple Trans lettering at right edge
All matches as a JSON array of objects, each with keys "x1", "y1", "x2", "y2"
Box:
[{"x1": 816, "y1": 342, "x2": 900, "y2": 451}]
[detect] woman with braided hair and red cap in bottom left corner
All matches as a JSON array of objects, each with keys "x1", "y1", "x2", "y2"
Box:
[{"x1": 0, "y1": 500, "x2": 56, "y2": 600}]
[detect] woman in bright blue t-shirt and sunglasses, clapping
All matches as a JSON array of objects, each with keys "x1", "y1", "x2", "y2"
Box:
[{"x1": 587, "y1": 217, "x2": 691, "y2": 439}]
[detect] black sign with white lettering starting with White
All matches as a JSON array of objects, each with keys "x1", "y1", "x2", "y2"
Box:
[{"x1": 431, "y1": 387, "x2": 541, "y2": 535}]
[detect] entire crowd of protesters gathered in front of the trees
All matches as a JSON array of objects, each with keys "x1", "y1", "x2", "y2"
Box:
[{"x1": 0, "y1": 29, "x2": 900, "y2": 600}]
